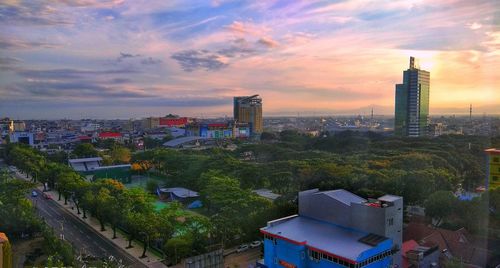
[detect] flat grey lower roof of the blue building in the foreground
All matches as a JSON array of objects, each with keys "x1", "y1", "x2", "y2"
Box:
[{"x1": 261, "y1": 216, "x2": 388, "y2": 261}]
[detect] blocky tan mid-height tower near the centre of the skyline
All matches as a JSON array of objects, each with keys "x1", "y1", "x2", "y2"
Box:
[{"x1": 234, "y1": 95, "x2": 264, "y2": 134}]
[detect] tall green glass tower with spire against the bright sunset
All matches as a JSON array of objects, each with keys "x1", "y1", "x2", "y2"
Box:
[{"x1": 394, "y1": 57, "x2": 430, "y2": 137}]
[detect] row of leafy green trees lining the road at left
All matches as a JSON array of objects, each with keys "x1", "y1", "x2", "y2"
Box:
[{"x1": 6, "y1": 145, "x2": 212, "y2": 264}]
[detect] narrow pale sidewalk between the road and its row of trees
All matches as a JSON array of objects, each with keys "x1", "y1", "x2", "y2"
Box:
[{"x1": 12, "y1": 172, "x2": 167, "y2": 268}]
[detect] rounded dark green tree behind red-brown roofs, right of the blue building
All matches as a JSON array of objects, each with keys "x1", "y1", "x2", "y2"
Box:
[{"x1": 425, "y1": 191, "x2": 458, "y2": 226}]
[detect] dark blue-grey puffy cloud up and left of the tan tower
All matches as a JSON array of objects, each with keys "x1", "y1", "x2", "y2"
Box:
[{"x1": 171, "y1": 49, "x2": 228, "y2": 72}]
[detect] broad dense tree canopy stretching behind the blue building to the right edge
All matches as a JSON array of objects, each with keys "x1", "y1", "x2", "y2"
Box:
[{"x1": 132, "y1": 131, "x2": 500, "y2": 233}]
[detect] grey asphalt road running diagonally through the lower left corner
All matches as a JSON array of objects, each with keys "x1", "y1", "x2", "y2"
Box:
[{"x1": 30, "y1": 190, "x2": 146, "y2": 267}]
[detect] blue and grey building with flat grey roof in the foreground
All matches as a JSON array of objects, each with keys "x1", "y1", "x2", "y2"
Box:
[{"x1": 258, "y1": 189, "x2": 403, "y2": 268}]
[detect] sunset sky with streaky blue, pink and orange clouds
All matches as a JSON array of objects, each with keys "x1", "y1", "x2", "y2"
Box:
[{"x1": 0, "y1": 0, "x2": 500, "y2": 119}]
